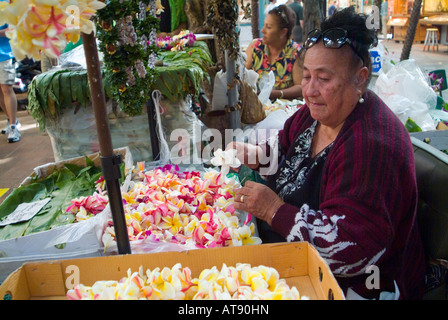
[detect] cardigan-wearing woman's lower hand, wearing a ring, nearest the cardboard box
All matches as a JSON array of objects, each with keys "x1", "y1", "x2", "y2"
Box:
[{"x1": 233, "y1": 181, "x2": 284, "y2": 225}]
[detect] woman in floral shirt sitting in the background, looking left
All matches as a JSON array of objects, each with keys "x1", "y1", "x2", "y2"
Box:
[{"x1": 245, "y1": 5, "x2": 302, "y2": 100}]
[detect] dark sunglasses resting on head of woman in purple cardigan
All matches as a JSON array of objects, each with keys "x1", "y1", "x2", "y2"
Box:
[{"x1": 303, "y1": 28, "x2": 365, "y2": 65}]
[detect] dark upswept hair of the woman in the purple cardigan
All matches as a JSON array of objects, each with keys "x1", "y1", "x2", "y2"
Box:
[{"x1": 320, "y1": 7, "x2": 378, "y2": 82}]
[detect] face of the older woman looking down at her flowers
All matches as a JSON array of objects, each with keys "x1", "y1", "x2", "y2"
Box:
[{"x1": 302, "y1": 42, "x2": 368, "y2": 128}]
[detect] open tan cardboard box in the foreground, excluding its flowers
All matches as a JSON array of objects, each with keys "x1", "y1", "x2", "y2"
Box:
[{"x1": 0, "y1": 242, "x2": 344, "y2": 300}]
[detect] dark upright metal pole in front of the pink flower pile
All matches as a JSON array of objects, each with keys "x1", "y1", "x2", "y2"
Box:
[{"x1": 81, "y1": 32, "x2": 131, "y2": 254}]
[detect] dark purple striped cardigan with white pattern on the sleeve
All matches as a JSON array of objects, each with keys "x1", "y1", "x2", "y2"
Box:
[{"x1": 272, "y1": 91, "x2": 424, "y2": 299}]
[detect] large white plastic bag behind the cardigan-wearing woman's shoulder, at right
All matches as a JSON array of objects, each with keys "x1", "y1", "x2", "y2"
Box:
[{"x1": 373, "y1": 60, "x2": 437, "y2": 131}]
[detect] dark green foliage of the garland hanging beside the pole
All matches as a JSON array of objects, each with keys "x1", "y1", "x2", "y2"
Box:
[{"x1": 97, "y1": 0, "x2": 159, "y2": 116}]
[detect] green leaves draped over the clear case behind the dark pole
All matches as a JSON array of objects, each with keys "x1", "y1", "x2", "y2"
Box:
[{"x1": 28, "y1": 41, "x2": 213, "y2": 131}]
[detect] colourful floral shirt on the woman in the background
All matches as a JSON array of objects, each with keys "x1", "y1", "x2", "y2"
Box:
[{"x1": 251, "y1": 39, "x2": 300, "y2": 90}]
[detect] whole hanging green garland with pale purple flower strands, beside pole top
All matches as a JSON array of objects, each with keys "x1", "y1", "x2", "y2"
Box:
[{"x1": 97, "y1": 0, "x2": 163, "y2": 116}]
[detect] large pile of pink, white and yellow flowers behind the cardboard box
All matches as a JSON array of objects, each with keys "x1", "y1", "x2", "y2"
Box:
[{"x1": 102, "y1": 163, "x2": 261, "y2": 248}]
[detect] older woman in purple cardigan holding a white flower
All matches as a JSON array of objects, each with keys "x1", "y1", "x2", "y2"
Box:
[{"x1": 229, "y1": 8, "x2": 424, "y2": 299}]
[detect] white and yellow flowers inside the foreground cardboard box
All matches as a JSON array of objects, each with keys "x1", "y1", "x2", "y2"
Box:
[{"x1": 67, "y1": 263, "x2": 308, "y2": 300}]
